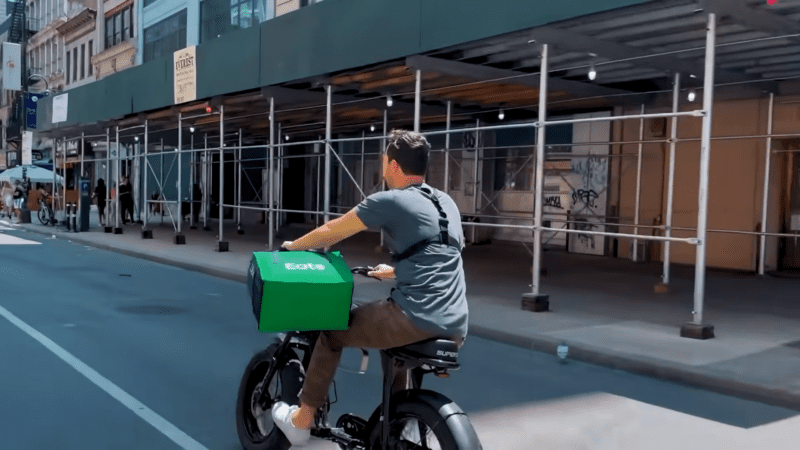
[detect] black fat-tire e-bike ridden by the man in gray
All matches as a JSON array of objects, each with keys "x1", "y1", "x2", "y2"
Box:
[{"x1": 236, "y1": 267, "x2": 483, "y2": 450}]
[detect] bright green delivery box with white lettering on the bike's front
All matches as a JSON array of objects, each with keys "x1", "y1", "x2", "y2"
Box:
[{"x1": 247, "y1": 251, "x2": 353, "y2": 332}]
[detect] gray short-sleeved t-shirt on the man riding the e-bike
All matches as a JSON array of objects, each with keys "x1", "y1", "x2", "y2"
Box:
[{"x1": 355, "y1": 183, "x2": 469, "y2": 337}]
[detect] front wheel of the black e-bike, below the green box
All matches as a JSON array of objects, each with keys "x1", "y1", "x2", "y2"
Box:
[{"x1": 236, "y1": 344, "x2": 305, "y2": 450}]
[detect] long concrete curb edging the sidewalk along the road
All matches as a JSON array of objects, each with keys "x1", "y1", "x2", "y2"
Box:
[{"x1": 21, "y1": 225, "x2": 800, "y2": 411}]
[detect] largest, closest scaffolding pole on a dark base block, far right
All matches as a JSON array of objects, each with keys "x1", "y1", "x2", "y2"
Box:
[{"x1": 681, "y1": 13, "x2": 717, "y2": 339}]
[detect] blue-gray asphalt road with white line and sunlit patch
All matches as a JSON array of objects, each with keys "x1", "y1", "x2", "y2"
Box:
[{"x1": 0, "y1": 224, "x2": 800, "y2": 450}]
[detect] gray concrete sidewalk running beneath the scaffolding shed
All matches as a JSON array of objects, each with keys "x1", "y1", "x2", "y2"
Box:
[{"x1": 14, "y1": 214, "x2": 800, "y2": 410}]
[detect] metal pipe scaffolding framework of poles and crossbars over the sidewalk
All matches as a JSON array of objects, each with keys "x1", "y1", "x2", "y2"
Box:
[{"x1": 47, "y1": 13, "x2": 800, "y2": 338}]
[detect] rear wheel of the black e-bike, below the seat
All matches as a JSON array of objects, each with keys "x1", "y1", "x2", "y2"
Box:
[{"x1": 369, "y1": 390, "x2": 483, "y2": 450}]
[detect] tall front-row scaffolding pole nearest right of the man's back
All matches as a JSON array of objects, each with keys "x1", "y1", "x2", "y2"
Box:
[{"x1": 522, "y1": 44, "x2": 549, "y2": 311}]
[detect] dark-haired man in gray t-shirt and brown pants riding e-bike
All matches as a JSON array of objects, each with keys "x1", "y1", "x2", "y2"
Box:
[{"x1": 272, "y1": 130, "x2": 468, "y2": 445}]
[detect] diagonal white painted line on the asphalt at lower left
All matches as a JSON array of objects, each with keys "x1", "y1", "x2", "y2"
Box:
[{"x1": 0, "y1": 306, "x2": 208, "y2": 450}]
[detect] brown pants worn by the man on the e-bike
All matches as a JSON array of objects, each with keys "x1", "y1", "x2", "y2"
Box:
[{"x1": 300, "y1": 300, "x2": 462, "y2": 409}]
